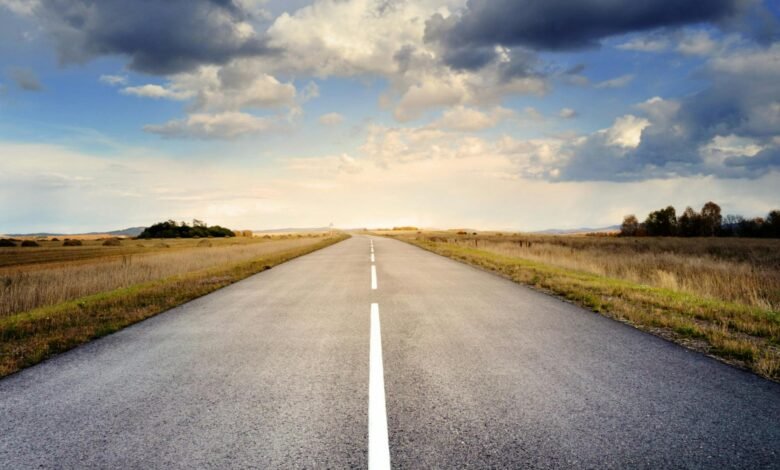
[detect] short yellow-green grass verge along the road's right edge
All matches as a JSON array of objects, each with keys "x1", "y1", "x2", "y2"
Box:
[{"x1": 394, "y1": 237, "x2": 780, "y2": 381}]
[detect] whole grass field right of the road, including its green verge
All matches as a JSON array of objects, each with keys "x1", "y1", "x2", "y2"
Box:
[{"x1": 379, "y1": 231, "x2": 780, "y2": 380}]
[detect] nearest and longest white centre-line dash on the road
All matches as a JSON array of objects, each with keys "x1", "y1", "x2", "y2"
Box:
[{"x1": 368, "y1": 303, "x2": 390, "y2": 470}]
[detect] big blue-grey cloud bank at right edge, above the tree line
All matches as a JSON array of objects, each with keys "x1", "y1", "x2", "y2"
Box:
[{"x1": 561, "y1": 43, "x2": 780, "y2": 181}]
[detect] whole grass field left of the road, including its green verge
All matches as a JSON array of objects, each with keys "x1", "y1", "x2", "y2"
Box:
[{"x1": 0, "y1": 234, "x2": 347, "y2": 377}]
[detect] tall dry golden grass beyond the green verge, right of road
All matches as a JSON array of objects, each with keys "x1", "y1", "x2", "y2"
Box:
[{"x1": 424, "y1": 233, "x2": 780, "y2": 311}]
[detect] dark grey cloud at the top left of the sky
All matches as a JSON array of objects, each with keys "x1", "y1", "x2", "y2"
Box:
[{"x1": 35, "y1": 0, "x2": 271, "y2": 74}]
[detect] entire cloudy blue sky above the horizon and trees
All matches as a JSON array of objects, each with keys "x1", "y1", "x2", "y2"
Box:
[{"x1": 0, "y1": 0, "x2": 780, "y2": 233}]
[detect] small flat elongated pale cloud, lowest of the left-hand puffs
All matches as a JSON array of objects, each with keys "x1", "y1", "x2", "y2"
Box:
[{"x1": 144, "y1": 112, "x2": 278, "y2": 139}]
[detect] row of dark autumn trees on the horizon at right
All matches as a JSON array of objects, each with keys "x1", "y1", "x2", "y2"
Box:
[{"x1": 620, "y1": 201, "x2": 780, "y2": 238}]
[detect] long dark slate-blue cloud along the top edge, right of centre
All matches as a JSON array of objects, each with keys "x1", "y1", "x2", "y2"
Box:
[{"x1": 426, "y1": 0, "x2": 754, "y2": 59}]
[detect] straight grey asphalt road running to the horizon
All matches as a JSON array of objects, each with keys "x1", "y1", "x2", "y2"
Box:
[{"x1": 0, "y1": 237, "x2": 780, "y2": 469}]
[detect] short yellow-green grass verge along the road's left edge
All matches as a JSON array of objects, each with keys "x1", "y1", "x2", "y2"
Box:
[{"x1": 0, "y1": 235, "x2": 348, "y2": 377}]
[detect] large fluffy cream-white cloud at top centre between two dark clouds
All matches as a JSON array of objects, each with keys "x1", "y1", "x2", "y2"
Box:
[{"x1": 263, "y1": 0, "x2": 547, "y2": 121}]
